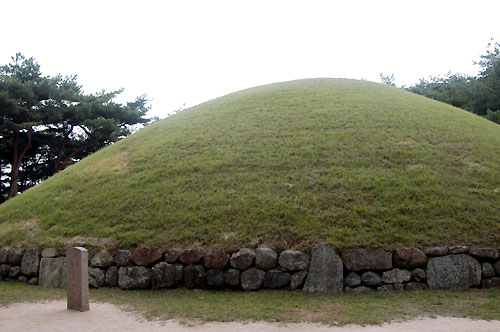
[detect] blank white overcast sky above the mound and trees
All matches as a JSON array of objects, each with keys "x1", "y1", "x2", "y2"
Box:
[{"x1": 0, "y1": 0, "x2": 500, "y2": 117}]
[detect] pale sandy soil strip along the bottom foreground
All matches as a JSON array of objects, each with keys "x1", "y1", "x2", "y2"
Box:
[{"x1": 0, "y1": 301, "x2": 500, "y2": 332}]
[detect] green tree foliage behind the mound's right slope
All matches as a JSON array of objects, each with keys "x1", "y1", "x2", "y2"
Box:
[{"x1": 407, "y1": 41, "x2": 500, "y2": 123}]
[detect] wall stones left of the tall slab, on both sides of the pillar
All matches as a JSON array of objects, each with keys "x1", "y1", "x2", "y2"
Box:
[{"x1": 0, "y1": 248, "x2": 309, "y2": 290}]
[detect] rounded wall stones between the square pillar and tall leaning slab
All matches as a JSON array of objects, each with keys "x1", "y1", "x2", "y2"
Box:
[{"x1": 89, "y1": 248, "x2": 309, "y2": 290}]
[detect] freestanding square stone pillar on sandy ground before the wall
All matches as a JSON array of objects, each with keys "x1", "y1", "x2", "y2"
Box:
[{"x1": 66, "y1": 247, "x2": 89, "y2": 311}]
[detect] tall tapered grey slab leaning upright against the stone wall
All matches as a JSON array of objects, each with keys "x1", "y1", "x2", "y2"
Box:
[{"x1": 303, "y1": 245, "x2": 344, "y2": 293}]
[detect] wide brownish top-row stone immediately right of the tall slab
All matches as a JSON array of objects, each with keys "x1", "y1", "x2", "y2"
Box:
[{"x1": 342, "y1": 248, "x2": 392, "y2": 272}]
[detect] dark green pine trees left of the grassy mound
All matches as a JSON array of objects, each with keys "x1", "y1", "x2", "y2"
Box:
[{"x1": 0, "y1": 53, "x2": 152, "y2": 202}]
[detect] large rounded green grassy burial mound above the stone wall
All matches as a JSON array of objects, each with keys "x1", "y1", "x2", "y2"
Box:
[{"x1": 0, "y1": 79, "x2": 500, "y2": 248}]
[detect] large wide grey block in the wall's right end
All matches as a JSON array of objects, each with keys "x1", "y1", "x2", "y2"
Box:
[{"x1": 427, "y1": 254, "x2": 482, "y2": 289}]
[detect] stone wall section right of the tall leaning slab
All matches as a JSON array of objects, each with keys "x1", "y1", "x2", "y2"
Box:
[{"x1": 342, "y1": 246, "x2": 500, "y2": 293}]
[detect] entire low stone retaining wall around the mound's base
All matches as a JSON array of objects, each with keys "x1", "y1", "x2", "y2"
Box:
[{"x1": 0, "y1": 245, "x2": 500, "y2": 293}]
